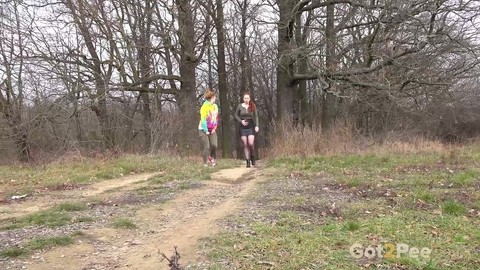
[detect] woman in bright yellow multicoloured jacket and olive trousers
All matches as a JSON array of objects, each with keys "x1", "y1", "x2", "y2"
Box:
[{"x1": 198, "y1": 89, "x2": 218, "y2": 166}]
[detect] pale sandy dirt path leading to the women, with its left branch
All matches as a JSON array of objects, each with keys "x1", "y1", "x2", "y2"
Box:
[{"x1": 0, "y1": 168, "x2": 267, "y2": 269}]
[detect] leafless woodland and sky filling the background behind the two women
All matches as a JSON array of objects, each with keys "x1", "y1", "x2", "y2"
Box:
[{"x1": 0, "y1": 0, "x2": 480, "y2": 160}]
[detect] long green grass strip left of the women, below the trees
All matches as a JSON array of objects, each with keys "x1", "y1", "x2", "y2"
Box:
[{"x1": 0, "y1": 155, "x2": 241, "y2": 198}]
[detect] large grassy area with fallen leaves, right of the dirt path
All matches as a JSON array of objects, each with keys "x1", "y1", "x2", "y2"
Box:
[{"x1": 198, "y1": 142, "x2": 480, "y2": 269}]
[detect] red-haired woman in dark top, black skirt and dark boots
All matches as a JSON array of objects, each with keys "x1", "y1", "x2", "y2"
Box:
[{"x1": 235, "y1": 93, "x2": 259, "y2": 168}]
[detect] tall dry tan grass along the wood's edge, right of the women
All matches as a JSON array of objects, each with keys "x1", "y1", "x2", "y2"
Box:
[{"x1": 267, "y1": 119, "x2": 468, "y2": 158}]
